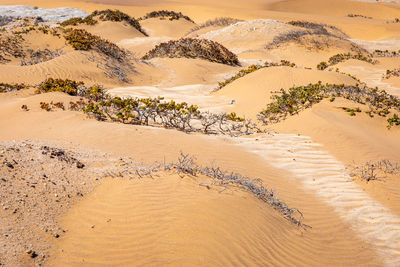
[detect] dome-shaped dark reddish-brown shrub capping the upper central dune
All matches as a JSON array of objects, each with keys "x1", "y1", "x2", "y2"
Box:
[{"x1": 142, "y1": 38, "x2": 240, "y2": 66}]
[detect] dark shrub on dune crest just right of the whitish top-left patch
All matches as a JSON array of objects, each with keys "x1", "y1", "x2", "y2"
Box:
[{"x1": 60, "y1": 9, "x2": 148, "y2": 36}]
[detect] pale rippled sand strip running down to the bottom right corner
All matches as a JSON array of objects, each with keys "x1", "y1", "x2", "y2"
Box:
[{"x1": 234, "y1": 134, "x2": 400, "y2": 266}]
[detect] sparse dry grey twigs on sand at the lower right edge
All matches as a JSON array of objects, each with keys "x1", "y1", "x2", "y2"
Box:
[{"x1": 350, "y1": 160, "x2": 400, "y2": 183}]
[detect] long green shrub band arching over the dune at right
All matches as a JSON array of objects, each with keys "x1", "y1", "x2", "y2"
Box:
[{"x1": 258, "y1": 82, "x2": 400, "y2": 129}]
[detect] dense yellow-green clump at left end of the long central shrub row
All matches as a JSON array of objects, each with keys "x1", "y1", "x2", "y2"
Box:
[{"x1": 35, "y1": 78, "x2": 83, "y2": 96}]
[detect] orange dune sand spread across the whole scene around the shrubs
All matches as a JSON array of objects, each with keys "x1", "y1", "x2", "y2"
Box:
[{"x1": 0, "y1": 0, "x2": 400, "y2": 266}]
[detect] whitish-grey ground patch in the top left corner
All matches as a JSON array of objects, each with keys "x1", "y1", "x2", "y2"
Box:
[{"x1": 0, "y1": 5, "x2": 89, "y2": 22}]
